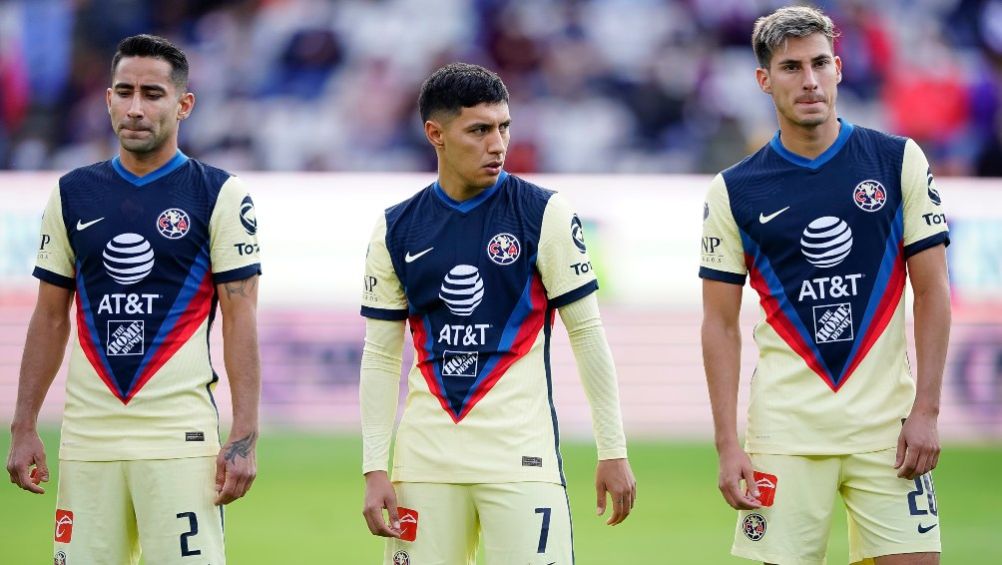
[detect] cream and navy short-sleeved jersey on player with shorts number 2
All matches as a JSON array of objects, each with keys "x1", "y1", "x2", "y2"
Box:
[{"x1": 34, "y1": 151, "x2": 261, "y2": 461}]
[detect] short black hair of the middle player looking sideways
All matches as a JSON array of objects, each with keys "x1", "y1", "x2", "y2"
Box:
[{"x1": 418, "y1": 63, "x2": 508, "y2": 121}]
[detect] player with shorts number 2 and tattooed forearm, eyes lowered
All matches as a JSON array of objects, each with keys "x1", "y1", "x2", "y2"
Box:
[{"x1": 7, "y1": 35, "x2": 261, "y2": 565}]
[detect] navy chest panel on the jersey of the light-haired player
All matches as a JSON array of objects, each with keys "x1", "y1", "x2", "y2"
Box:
[{"x1": 723, "y1": 127, "x2": 905, "y2": 390}]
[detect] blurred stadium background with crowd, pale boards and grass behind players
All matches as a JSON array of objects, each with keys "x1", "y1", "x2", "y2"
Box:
[{"x1": 0, "y1": 0, "x2": 1002, "y2": 565}]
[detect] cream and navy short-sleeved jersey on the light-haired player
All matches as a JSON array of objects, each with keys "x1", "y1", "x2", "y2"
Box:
[{"x1": 699, "y1": 121, "x2": 949, "y2": 455}]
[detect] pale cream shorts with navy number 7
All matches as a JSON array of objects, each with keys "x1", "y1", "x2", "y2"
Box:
[{"x1": 383, "y1": 482, "x2": 574, "y2": 565}]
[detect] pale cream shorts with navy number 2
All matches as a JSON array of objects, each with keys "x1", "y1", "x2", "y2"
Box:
[{"x1": 54, "y1": 457, "x2": 225, "y2": 565}]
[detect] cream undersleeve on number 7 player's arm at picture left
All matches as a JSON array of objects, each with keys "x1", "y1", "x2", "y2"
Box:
[{"x1": 359, "y1": 320, "x2": 404, "y2": 474}]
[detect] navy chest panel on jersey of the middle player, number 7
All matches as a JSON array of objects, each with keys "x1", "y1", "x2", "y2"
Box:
[{"x1": 386, "y1": 175, "x2": 552, "y2": 419}]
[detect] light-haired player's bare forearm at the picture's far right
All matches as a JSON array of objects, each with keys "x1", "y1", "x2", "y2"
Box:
[{"x1": 912, "y1": 281, "x2": 951, "y2": 417}]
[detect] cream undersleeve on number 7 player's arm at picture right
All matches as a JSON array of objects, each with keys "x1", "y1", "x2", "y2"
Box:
[{"x1": 559, "y1": 294, "x2": 626, "y2": 460}]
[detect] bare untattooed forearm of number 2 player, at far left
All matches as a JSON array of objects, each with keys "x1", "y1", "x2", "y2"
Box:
[{"x1": 11, "y1": 310, "x2": 70, "y2": 431}]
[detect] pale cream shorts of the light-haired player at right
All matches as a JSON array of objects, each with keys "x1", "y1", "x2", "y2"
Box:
[{"x1": 731, "y1": 449, "x2": 941, "y2": 565}]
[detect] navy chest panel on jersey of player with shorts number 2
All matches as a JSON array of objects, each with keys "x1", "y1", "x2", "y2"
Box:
[{"x1": 60, "y1": 156, "x2": 229, "y2": 399}]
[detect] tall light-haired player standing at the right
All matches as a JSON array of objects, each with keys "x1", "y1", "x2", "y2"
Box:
[{"x1": 699, "y1": 7, "x2": 950, "y2": 565}]
